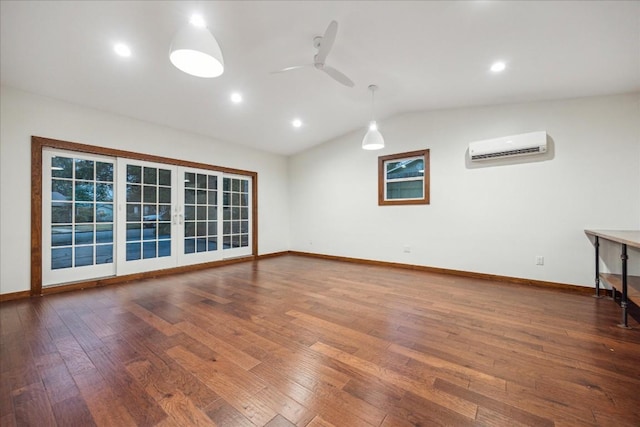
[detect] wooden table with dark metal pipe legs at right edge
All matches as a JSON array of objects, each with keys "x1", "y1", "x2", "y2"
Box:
[{"x1": 584, "y1": 230, "x2": 640, "y2": 328}]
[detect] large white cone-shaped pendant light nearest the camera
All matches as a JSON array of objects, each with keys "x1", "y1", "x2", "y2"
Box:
[{"x1": 169, "y1": 15, "x2": 224, "y2": 78}]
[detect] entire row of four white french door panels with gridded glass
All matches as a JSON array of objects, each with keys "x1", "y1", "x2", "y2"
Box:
[{"x1": 42, "y1": 149, "x2": 253, "y2": 286}]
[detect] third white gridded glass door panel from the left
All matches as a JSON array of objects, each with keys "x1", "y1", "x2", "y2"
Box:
[{"x1": 178, "y1": 167, "x2": 222, "y2": 265}]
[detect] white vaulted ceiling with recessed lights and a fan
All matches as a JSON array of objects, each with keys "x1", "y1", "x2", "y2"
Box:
[{"x1": 0, "y1": 0, "x2": 640, "y2": 154}]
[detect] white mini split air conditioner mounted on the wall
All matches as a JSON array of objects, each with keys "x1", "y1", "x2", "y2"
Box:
[{"x1": 469, "y1": 131, "x2": 547, "y2": 161}]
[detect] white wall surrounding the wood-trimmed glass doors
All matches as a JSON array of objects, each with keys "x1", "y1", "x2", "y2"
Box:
[{"x1": 0, "y1": 86, "x2": 289, "y2": 293}]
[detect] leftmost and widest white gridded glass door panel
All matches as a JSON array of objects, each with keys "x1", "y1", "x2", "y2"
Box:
[{"x1": 42, "y1": 149, "x2": 115, "y2": 286}]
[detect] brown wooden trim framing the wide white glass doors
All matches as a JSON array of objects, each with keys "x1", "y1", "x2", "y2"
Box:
[{"x1": 31, "y1": 136, "x2": 258, "y2": 295}]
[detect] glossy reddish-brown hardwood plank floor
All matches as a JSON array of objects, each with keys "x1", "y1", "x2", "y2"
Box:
[{"x1": 0, "y1": 256, "x2": 640, "y2": 427}]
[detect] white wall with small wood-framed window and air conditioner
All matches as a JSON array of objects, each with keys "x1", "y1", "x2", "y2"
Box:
[{"x1": 289, "y1": 93, "x2": 640, "y2": 286}]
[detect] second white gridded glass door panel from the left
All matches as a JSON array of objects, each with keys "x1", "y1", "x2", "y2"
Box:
[{"x1": 118, "y1": 159, "x2": 177, "y2": 274}]
